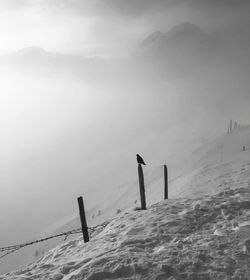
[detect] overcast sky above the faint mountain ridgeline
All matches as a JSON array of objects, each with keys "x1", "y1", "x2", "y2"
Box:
[{"x1": 0, "y1": 0, "x2": 250, "y2": 56}]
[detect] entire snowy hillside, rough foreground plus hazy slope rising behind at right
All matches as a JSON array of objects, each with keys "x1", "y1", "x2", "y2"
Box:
[{"x1": 0, "y1": 126, "x2": 250, "y2": 280}]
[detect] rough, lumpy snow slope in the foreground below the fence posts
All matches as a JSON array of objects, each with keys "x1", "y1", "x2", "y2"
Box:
[{"x1": 0, "y1": 183, "x2": 250, "y2": 280}]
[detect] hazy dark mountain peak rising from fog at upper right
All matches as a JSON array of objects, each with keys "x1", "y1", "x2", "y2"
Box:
[{"x1": 137, "y1": 22, "x2": 215, "y2": 64}]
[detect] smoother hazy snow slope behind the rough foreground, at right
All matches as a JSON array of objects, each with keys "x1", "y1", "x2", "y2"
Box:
[{"x1": 170, "y1": 126, "x2": 250, "y2": 197}]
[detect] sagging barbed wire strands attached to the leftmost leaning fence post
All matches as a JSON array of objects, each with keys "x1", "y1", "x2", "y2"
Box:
[{"x1": 0, "y1": 221, "x2": 109, "y2": 259}]
